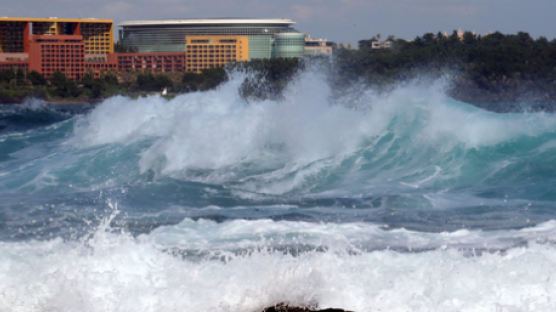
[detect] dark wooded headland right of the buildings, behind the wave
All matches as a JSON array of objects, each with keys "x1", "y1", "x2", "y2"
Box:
[{"x1": 335, "y1": 31, "x2": 556, "y2": 106}]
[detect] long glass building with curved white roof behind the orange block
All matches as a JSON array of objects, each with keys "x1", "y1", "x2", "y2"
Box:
[{"x1": 119, "y1": 18, "x2": 305, "y2": 60}]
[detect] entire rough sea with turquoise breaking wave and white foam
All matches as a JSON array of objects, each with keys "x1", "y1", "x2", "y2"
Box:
[{"x1": 0, "y1": 69, "x2": 556, "y2": 312}]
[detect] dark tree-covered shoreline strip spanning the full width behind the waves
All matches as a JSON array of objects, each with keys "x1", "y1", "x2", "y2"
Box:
[{"x1": 0, "y1": 32, "x2": 556, "y2": 112}]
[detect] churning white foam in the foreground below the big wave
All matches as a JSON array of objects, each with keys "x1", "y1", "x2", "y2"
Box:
[{"x1": 0, "y1": 221, "x2": 556, "y2": 312}]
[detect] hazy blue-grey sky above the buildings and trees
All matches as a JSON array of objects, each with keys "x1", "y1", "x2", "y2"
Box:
[{"x1": 0, "y1": 0, "x2": 556, "y2": 43}]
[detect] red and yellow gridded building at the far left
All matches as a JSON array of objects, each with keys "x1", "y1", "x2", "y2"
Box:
[{"x1": 0, "y1": 17, "x2": 114, "y2": 79}]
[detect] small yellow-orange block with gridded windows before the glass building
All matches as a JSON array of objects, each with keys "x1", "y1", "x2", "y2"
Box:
[{"x1": 185, "y1": 35, "x2": 249, "y2": 73}]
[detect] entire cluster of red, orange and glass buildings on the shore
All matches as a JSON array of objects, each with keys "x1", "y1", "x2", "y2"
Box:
[{"x1": 0, "y1": 17, "x2": 312, "y2": 80}]
